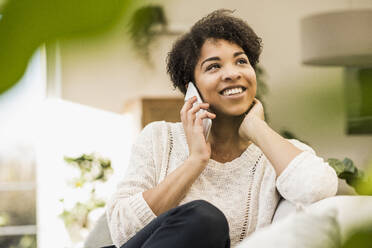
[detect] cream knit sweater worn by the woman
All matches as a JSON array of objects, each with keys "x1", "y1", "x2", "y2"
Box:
[{"x1": 106, "y1": 121, "x2": 338, "y2": 247}]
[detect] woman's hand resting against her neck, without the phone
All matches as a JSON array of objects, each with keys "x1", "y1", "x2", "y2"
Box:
[{"x1": 239, "y1": 98, "x2": 265, "y2": 142}]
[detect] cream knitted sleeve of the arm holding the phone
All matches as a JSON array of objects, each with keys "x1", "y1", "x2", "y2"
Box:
[{"x1": 106, "y1": 124, "x2": 160, "y2": 247}]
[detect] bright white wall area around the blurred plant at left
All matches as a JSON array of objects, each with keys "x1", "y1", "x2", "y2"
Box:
[{"x1": 35, "y1": 99, "x2": 138, "y2": 248}]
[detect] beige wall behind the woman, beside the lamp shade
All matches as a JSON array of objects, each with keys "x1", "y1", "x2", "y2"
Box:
[{"x1": 57, "y1": 0, "x2": 372, "y2": 193}]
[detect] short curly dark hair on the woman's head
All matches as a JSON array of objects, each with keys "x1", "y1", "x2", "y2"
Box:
[{"x1": 167, "y1": 9, "x2": 262, "y2": 94}]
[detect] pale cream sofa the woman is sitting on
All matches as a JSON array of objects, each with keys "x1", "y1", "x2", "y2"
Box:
[{"x1": 84, "y1": 195, "x2": 372, "y2": 248}]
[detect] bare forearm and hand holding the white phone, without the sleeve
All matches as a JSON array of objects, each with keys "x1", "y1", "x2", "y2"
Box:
[{"x1": 143, "y1": 97, "x2": 215, "y2": 215}]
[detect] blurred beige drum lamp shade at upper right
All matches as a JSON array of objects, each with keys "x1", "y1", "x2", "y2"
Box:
[{"x1": 301, "y1": 9, "x2": 372, "y2": 67}]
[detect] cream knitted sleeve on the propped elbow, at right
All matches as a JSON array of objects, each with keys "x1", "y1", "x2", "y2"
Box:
[{"x1": 276, "y1": 140, "x2": 338, "y2": 204}]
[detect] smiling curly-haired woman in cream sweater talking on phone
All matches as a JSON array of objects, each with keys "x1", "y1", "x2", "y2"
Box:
[{"x1": 107, "y1": 10, "x2": 337, "y2": 248}]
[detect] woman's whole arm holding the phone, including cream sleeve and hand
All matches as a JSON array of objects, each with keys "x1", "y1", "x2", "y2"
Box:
[{"x1": 106, "y1": 97, "x2": 214, "y2": 247}]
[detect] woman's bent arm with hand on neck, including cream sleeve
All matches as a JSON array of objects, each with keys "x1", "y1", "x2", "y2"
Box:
[{"x1": 239, "y1": 100, "x2": 338, "y2": 204}]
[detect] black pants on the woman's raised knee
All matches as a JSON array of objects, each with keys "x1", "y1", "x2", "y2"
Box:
[{"x1": 115, "y1": 200, "x2": 230, "y2": 248}]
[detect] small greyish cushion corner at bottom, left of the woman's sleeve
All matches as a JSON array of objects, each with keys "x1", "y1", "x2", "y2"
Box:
[{"x1": 84, "y1": 214, "x2": 113, "y2": 248}]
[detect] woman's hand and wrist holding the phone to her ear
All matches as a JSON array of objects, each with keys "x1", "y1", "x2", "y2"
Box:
[{"x1": 180, "y1": 96, "x2": 216, "y2": 165}]
